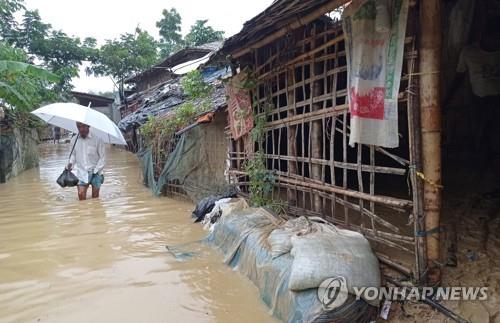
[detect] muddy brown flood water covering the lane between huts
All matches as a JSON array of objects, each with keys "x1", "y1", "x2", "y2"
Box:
[{"x1": 0, "y1": 144, "x2": 274, "y2": 322}]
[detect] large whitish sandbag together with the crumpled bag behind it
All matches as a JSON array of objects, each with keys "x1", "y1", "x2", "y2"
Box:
[{"x1": 268, "y1": 217, "x2": 381, "y2": 306}]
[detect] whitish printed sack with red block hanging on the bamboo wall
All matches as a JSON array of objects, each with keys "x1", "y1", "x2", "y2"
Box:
[{"x1": 342, "y1": 0, "x2": 408, "y2": 148}]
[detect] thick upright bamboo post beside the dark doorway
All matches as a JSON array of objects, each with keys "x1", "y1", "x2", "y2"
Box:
[{"x1": 420, "y1": 0, "x2": 441, "y2": 285}]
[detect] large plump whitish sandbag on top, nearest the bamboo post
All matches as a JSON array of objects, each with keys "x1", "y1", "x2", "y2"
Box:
[{"x1": 288, "y1": 225, "x2": 380, "y2": 305}]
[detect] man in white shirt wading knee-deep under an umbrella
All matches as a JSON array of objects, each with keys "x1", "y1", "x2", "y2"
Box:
[{"x1": 66, "y1": 122, "x2": 106, "y2": 201}]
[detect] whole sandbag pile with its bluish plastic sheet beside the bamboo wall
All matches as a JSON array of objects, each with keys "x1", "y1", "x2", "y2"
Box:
[{"x1": 205, "y1": 210, "x2": 380, "y2": 323}]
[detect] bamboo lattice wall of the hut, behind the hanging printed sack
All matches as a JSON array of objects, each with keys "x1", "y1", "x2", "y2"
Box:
[{"x1": 228, "y1": 9, "x2": 426, "y2": 279}]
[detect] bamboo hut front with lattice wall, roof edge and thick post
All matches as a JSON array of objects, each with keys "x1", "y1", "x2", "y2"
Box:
[{"x1": 219, "y1": 0, "x2": 441, "y2": 284}]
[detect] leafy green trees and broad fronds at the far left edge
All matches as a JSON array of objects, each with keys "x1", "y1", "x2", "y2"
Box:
[{"x1": 0, "y1": 0, "x2": 96, "y2": 119}]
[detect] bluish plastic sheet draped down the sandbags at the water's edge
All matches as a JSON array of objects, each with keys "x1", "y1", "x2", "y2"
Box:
[{"x1": 205, "y1": 208, "x2": 377, "y2": 322}]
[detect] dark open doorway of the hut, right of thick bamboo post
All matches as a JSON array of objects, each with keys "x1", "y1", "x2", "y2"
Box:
[{"x1": 441, "y1": 1, "x2": 500, "y2": 319}]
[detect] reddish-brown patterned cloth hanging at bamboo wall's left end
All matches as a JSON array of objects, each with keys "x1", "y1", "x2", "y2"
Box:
[{"x1": 226, "y1": 73, "x2": 253, "y2": 139}]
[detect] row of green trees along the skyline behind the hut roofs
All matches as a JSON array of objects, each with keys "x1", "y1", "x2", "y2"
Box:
[{"x1": 0, "y1": 0, "x2": 224, "y2": 102}]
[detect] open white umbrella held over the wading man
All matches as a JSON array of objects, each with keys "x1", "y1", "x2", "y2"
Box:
[{"x1": 31, "y1": 103, "x2": 127, "y2": 145}]
